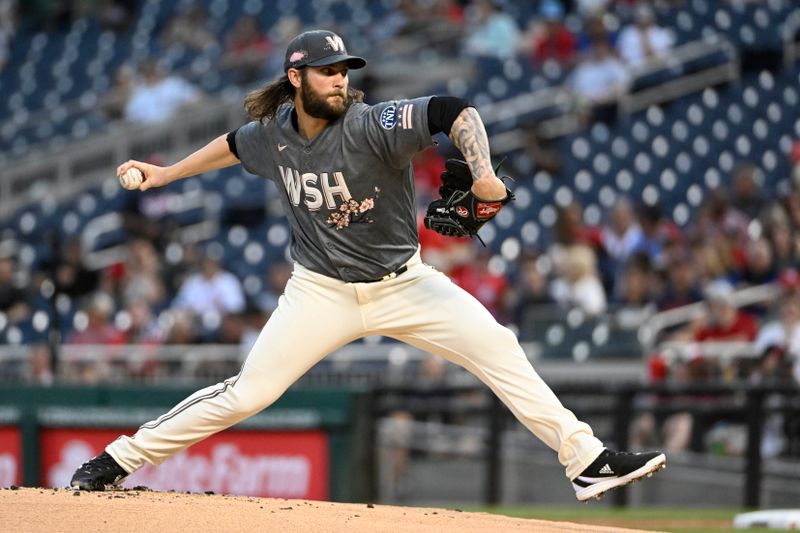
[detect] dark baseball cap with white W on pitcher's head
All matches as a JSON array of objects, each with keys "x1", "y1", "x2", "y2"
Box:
[{"x1": 283, "y1": 30, "x2": 367, "y2": 72}]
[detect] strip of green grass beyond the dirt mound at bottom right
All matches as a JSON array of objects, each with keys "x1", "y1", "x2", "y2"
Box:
[{"x1": 464, "y1": 505, "x2": 777, "y2": 533}]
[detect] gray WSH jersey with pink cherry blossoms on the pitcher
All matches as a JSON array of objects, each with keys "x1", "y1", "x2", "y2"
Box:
[{"x1": 236, "y1": 96, "x2": 433, "y2": 282}]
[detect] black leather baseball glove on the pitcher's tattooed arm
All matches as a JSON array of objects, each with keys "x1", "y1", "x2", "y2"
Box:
[{"x1": 424, "y1": 159, "x2": 514, "y2": 246}]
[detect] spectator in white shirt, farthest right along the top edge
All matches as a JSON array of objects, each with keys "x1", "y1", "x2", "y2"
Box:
[{"x1": 617, "y1": 3, "x2": 675, "y2": 66}]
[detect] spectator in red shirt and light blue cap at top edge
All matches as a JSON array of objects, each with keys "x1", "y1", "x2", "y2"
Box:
[{"x1": 523, "y1": 0, "x2": 577, "y2": 65}]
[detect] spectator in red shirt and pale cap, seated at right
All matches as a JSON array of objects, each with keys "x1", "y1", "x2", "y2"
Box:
[{"x1": 694, "y1": 279, "x2": 758, "y2": 342}]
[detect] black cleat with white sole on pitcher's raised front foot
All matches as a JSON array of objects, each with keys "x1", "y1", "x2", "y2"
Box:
[{"x1": 572, "y1": 450, "x2": 667, "y2": 502}]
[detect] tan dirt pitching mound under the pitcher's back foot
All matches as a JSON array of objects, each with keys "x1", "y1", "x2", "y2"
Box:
[{"x1": 0, "y1": 488, "x2": 664, "y2": 533}]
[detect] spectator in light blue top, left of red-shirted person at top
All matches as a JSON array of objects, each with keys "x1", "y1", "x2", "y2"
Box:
[{"x1": 464, "y1": 0, "x2": 520, "y2": 59}]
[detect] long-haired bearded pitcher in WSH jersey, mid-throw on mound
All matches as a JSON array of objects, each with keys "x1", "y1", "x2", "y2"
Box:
[{"x1": 71, "y1": 30, "x2": 666, "y2": 500}]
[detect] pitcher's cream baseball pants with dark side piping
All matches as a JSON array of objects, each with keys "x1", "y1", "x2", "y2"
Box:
[{"x1": 106, "y1": 252, "x2": 603, "y2": 479}]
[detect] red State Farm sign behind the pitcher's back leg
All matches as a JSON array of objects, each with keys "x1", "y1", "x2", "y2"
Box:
[{"x1": 41, "y1": 428, "x2": 329, "y2": 500}]
